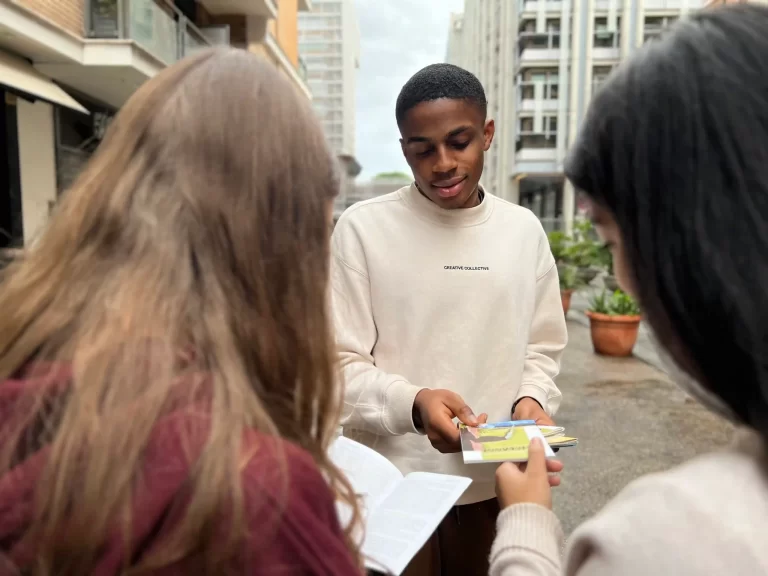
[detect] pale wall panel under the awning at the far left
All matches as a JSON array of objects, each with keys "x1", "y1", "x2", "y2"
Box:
[{"x1": 16, "y1": 98, "x2": 56, "y2": 246}]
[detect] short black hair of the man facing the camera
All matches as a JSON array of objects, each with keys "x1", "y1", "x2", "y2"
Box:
[{"x1": 395, "y1": 64, "x2": 488, "y2": 126}]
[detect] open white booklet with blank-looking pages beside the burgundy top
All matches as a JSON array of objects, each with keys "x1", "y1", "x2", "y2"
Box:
[{"x1": 330, "y1": 436, "x2": 472, "y2": 575}]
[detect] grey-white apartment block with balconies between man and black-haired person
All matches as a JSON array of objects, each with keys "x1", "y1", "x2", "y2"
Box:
[{"x1": 449, "y1": 0, "x2": 703, "y2": 229}]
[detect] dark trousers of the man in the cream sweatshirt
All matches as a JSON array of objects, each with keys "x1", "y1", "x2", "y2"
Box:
[{"x1": 403, "y1": 498, "x2": 499, "y2": 576}]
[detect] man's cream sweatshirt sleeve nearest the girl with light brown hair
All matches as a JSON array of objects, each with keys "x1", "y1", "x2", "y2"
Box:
[{"x1": 331, "y1": 217, "x2": 423, "y2": 436}]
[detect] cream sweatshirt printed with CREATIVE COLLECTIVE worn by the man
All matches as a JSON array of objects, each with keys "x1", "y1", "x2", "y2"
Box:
[{"x1": 331, "y1": 185, "x2": 567, "y2": 504}]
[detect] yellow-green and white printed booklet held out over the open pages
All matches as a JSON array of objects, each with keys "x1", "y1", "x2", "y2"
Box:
[{"x1": 459, "y1": 421, "x2": 559, "y2": 464}]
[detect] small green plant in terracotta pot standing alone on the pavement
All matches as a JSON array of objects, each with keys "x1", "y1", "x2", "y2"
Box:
[{"x1": 586, "y1": 290, "x2": 641, "y2": 356}]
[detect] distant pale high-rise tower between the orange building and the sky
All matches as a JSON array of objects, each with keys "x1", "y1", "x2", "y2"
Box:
[{"x1": 299, "y1": 0, "x2": 361, "y2": 213}]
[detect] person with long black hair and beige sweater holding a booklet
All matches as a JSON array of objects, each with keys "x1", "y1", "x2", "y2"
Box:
[{"x1": 491, "y1": 4, "x2": 768, "y2": 576}]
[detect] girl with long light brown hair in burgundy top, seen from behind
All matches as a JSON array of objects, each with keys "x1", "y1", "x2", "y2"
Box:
[{"x1": 0, "y1": 49, "x2": 361, "y2": 576}]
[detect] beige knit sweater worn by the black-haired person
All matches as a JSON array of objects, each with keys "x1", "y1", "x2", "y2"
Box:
[{"x1": 491, "y1": 432, "x2": 768, "y2": 576}]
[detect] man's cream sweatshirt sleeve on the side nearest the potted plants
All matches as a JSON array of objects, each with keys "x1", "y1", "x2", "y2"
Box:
[{"x1": 515, "y1": 225, "x2": 568, "y2": 416}]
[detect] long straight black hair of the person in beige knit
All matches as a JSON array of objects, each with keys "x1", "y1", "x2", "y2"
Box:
[{"x1": 565, "y1": 4, "x2": 768, "y2": 439}]
